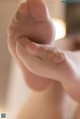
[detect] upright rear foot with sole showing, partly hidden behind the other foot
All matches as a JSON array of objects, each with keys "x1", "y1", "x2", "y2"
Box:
[{"x1": 8, "y1": 0, "x2": 55, "y2": 90}]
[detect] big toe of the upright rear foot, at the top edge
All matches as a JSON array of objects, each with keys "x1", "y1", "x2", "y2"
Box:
[{"x1": 27, "y1": 0, "x2": 49, "y2": 22}]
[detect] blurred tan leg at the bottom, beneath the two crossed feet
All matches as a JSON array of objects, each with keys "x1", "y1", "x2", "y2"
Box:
[{"x1": 16, "y1": 82, "x2": 68, "y2": 119}]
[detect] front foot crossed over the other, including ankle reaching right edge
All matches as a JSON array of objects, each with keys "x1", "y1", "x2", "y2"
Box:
[{"x1": 16, "y1": 36, "x2": 80, "y2": 101}]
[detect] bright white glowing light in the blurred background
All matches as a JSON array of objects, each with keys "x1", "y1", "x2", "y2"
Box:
[{"x1": 53, "y1": 18, "x2": 66, "y2": 40}]
